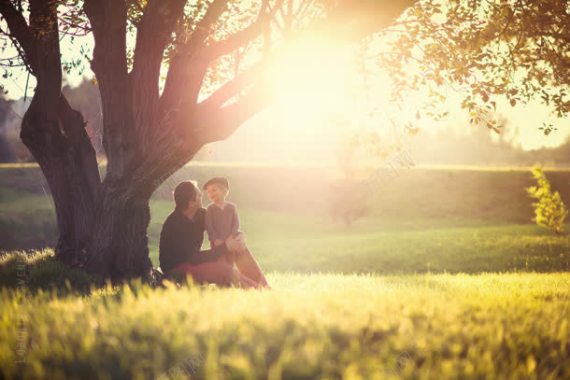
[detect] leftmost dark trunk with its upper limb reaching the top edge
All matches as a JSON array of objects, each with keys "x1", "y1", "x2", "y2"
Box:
[{"x1": 15, "y1": 0, "x2": 100, "y2": 264}]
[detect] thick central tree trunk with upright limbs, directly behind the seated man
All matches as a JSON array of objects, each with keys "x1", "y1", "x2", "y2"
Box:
[{"x1": 80, "y1": 0, "x2": 186, "y2": 280}]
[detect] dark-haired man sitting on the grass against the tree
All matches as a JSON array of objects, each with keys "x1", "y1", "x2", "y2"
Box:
[{"x1": 159, "y1": 181, "x2": 260, "y2": 287}]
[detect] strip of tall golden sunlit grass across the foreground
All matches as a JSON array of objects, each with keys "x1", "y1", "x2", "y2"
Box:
[{"x1": 0, "y1": 273, "x2": 570, "y2": 379}]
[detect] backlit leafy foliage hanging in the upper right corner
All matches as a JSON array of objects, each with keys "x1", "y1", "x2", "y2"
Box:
[{"x1": 383, "y1": 0, "x2": 570, "y2": 133}]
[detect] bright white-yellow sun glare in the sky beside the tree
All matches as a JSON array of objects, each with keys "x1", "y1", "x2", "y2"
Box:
[{"x1": 254, "y1": 36, "x2": 414, "y2": 162}]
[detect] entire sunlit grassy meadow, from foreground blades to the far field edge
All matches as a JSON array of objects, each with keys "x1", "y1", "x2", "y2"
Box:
[{"x1": 0, "y1": 165, "x2": 570, "y2": 379}]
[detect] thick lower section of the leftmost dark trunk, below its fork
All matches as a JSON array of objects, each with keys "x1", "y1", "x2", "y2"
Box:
[{"x1": 21, "y1": 95, "x2": 99, "y2": 265}]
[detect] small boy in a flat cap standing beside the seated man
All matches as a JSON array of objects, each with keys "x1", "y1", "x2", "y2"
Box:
[{"x1": 203, "y1": 177, "x2": 268, "y2": 286}]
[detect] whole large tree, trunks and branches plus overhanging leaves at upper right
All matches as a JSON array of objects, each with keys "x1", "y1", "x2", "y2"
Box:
[{"x1": 0, "y1": 0, "x2": 568, "y2": 278}]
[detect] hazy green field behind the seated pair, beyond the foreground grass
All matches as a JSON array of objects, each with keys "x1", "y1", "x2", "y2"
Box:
[{"x1": 0, "y1": 165, "x2": 570, "y2": 273}]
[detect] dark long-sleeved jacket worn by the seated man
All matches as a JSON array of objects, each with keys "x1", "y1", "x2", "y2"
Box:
[{"x1": 158, "y1": 208, "x2": 226, "y2": 274}]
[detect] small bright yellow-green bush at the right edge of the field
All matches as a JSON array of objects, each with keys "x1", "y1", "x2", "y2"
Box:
[{"x1": 526, "y1": 167, "x2": 568, "y2": 234}]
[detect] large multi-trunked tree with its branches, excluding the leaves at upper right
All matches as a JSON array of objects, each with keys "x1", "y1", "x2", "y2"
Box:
[{"x1": 0, "y1": 0, "x2": 411, "y2": 278}]
